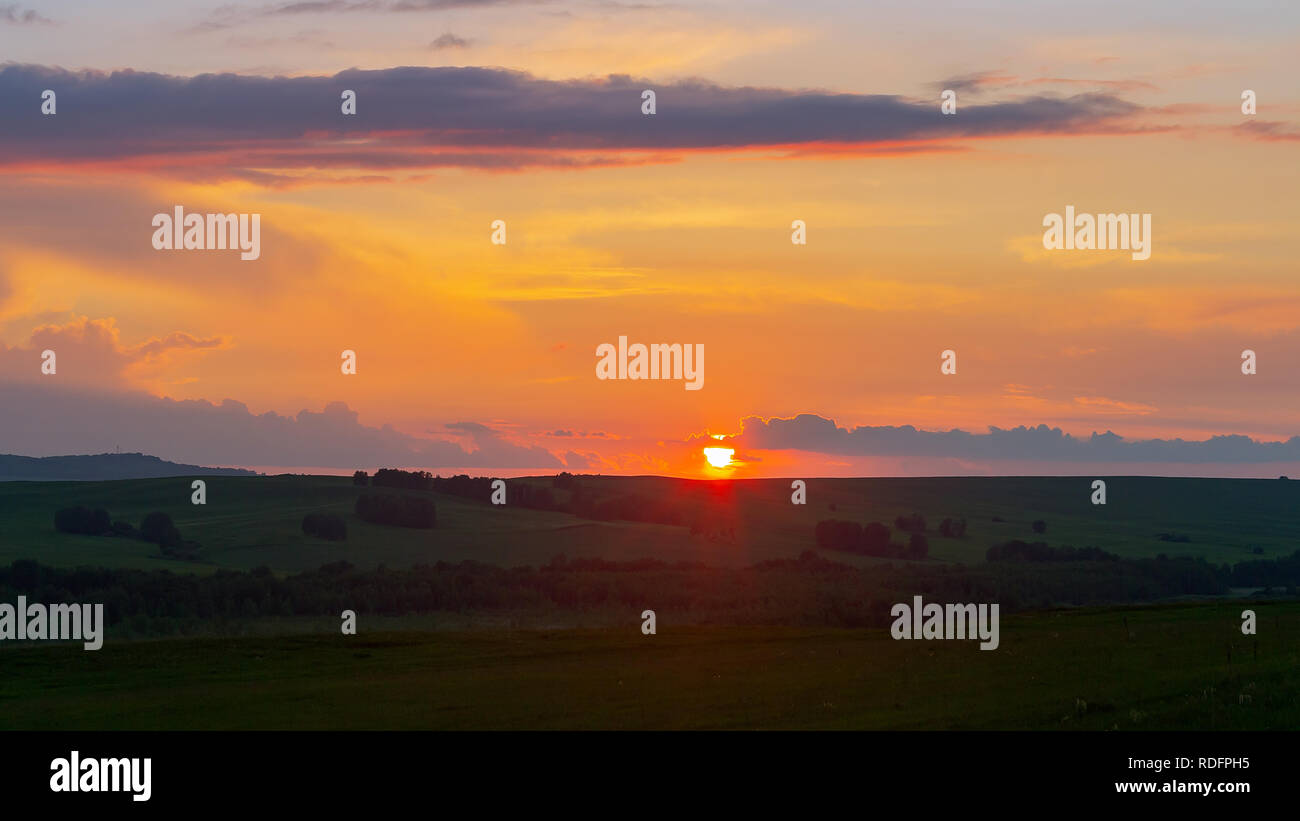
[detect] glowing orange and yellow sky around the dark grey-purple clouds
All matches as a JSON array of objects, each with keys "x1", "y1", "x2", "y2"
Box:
[{"x1": 0, "y1": 5, "x2": 1300, "y2": 475}]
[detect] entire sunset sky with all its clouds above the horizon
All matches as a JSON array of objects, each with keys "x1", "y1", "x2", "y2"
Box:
[{"x1": 0, "y1": 0, "x2": 1300, "y2": 478}]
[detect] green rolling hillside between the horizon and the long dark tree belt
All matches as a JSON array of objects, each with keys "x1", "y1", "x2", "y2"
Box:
[{"x1": 0, "y1": 477, "x2": 1300, "y2": 573}]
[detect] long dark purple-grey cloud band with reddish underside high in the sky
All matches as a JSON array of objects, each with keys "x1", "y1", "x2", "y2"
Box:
[{"x1": 0, "y1": 65, "x2": 1140, "y2": 177}]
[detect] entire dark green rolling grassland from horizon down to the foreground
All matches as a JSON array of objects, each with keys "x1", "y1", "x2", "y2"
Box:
[{"x1": 0, "y1": 475, "x2": 1300, "y2": 730}]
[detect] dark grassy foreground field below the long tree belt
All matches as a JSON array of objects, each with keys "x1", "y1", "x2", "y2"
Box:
[{"x1": 0, "y1": 603, "x2": 1300, "y2": 730}]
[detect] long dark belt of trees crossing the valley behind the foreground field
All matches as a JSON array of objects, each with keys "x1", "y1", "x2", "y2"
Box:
[{"x1": 0, "y1": 551, "x2": 1300, "y2": 631}]
